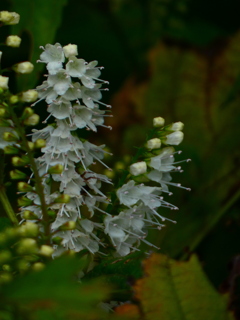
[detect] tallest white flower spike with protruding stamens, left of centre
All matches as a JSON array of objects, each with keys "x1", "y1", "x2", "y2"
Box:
[{"x1": 22, "y1": 43, "x2": 111, "y2": 255}]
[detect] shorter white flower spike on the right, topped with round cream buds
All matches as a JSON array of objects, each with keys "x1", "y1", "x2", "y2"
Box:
[{"x1": 105, "y1": 117, "x2": 190, "y2": 256}]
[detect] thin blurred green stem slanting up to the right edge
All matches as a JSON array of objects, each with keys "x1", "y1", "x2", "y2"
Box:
[{"x1": 181, "y1": 190, "x2": 240, "y2": 260}]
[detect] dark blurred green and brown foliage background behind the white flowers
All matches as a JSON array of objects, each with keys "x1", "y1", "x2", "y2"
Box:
[{"x1": 0, "y1": 0, "x2": 240, "y2": 306}]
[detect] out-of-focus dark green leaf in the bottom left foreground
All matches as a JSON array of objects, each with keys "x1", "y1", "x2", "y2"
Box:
[{"x1": 4, "y1": 257, "x2": 109, "y2": 319}]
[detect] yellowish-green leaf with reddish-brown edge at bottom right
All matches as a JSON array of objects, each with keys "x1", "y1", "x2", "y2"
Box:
[{"x1": 117, "y1": 254, "x2": 234, "y2": 320}]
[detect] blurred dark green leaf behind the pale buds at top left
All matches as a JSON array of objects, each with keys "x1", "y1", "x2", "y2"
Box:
[{"x1": 12, "y1": 0, "x2": 67, "y2": 90}]
